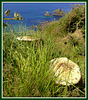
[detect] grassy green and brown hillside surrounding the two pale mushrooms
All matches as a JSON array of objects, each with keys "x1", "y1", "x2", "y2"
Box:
[{"x1": 3, "y1": 5, "x2": 85, "y2": 97}]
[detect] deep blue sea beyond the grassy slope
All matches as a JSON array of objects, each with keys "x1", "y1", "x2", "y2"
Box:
[{"x1": 3, "y1": 2, "x2": 84, "y2": 31}]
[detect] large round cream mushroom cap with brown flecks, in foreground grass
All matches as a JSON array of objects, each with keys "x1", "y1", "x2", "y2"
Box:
[{"x1": 50, "y1": 57, "x2": 81, "y2": 86}]
